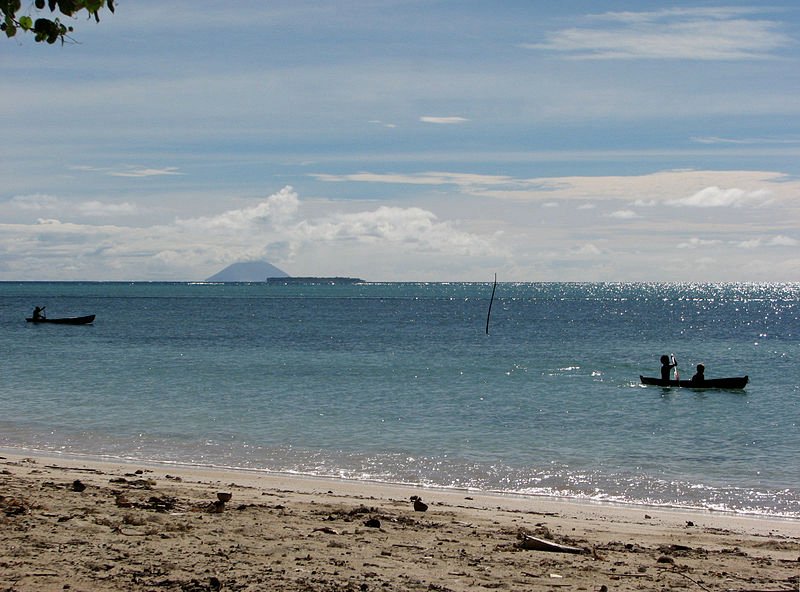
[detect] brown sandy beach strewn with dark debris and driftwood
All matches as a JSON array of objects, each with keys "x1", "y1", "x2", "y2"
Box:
[{"x1": 0, "y1": 453, "x2": 800, "y2": 592}]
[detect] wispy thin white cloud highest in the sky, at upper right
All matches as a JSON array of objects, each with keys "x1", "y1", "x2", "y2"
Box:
[{"x1": 523, "y1": 8, "x2": 792, "y2": 60}]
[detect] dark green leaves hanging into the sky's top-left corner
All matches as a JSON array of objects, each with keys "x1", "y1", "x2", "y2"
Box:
[{"x1": 0, "y1": 0, "x2": 114, "y2": 44}]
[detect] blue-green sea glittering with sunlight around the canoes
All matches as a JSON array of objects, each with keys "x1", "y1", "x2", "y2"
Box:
[{"x1": 0, "y1": 283, "x2": 800, "y2": 518}]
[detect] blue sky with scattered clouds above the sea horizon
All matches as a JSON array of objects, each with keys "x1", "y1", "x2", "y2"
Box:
[{"x1": 0, "y1": 0, "x2": 800, "y2": 282}]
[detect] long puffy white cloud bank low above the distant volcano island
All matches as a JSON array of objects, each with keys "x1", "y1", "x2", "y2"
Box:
[{"x1": 0, "y1": 187, "x2": 500, "y2": 279}]
